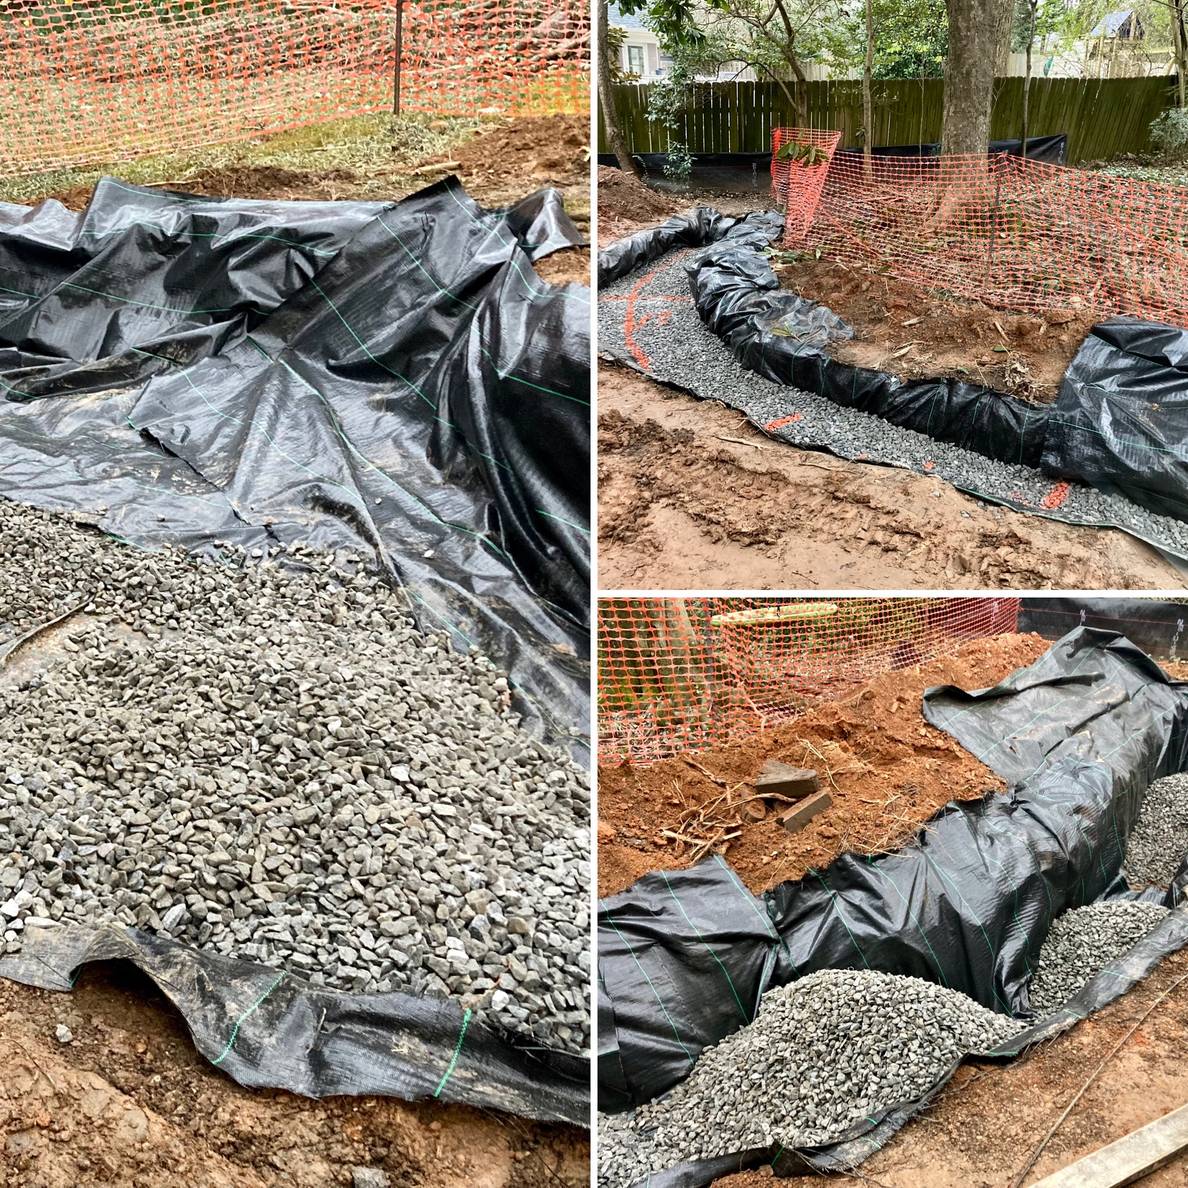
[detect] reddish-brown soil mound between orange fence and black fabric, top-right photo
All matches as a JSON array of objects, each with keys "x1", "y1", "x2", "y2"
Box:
[{"x1": 773, "y1": 253, "x2": 1099, "y2": 404}]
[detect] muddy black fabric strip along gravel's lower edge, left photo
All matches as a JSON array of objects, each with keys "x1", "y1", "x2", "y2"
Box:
[{"x1": 0, "y1": 925, "x2": 589, "y2": 1126}]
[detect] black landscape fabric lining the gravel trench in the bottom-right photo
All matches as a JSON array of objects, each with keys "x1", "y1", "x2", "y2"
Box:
[{"x1": 599, "y1": 627, "x2": 1188, "y2": 1188}]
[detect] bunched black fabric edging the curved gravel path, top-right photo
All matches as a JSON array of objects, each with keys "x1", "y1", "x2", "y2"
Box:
[{"x1": 599, "y1": 207, "x2": 1188, "y2": 541}]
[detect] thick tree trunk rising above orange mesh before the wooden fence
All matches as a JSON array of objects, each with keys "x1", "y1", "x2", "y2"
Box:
[{"x1": 941, "y1": 0, "x2": 1006, "y2": 154}]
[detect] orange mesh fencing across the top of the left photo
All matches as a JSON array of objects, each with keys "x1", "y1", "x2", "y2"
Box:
[{"x1": 0, "y1": 0, "x2": 589, "y2": 173}]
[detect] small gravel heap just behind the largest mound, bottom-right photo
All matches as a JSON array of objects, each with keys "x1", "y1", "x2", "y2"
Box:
[{"x1": 1030, "y1": 899, "x2": 1168, "y2": 1015}]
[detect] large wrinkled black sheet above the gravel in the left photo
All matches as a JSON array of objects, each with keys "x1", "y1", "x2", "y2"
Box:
[{"x1": 0, "y1": 178, "x2": 589, "y2": 751}]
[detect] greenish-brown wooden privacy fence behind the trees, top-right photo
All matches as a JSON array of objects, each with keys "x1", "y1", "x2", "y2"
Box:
[{"x1": 599, "y1": 77, "x2": 1173, "y2": 164}]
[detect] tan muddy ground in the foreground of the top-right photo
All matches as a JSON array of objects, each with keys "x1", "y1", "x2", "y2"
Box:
[{"x1": 599, "y1": 361, "x2": 1184, "y2": 590}]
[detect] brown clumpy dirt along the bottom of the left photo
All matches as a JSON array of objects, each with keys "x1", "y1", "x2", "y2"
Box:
[{"x1": 0, "y1": 966, "x2": 589, "y2": 1188}]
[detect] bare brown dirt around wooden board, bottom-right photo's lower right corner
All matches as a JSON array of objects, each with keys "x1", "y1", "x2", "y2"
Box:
[{"x1": 715, "y1": 952, "x2": 1188, "y2": 1188}]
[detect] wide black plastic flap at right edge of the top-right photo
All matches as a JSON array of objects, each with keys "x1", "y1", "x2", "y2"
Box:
[{"x1": 1043, "y1": 318, "x2": 1188, "y2": 520}]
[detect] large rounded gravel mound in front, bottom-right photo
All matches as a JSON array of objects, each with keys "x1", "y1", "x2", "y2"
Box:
[{"x1": 599, "y1": 969, "x2": 1022, "y2": 1188}]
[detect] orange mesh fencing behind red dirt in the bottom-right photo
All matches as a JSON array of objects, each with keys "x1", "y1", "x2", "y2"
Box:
[{"x1": 598, "y1": 598, "x2": 1019, "y2": 764}]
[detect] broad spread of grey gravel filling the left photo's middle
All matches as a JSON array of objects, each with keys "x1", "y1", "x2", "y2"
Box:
[{"x1": 0, "y1": 500, "x2": 589, "y2": 1051}]
